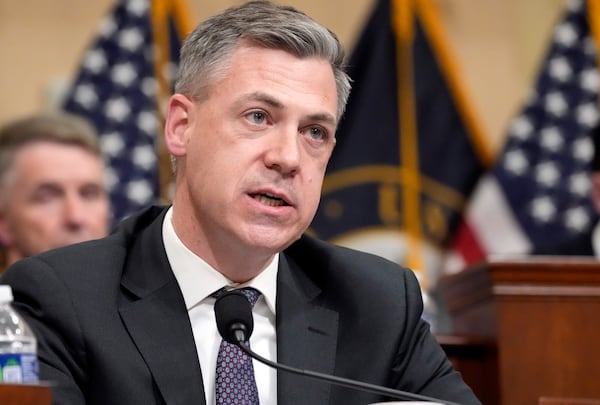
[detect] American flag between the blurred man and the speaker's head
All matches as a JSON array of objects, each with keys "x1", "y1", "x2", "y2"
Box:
[{"x1": 64, "y1": 0, "x2": 191, "y2": 221}]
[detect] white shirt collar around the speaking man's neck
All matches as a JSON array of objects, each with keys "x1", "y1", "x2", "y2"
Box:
[{"x1": 163, "y1": 206, "x2": 279, "y2": 314}]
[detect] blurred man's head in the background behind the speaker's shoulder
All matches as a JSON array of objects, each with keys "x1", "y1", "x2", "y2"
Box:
[{"x1": 0, "y1": 113, "x2": 110, "y2": 268}]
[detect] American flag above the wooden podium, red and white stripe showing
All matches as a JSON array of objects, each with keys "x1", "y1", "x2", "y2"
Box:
[{"x1": 450, "y1": 0, "x2": 600, "y2": 264}]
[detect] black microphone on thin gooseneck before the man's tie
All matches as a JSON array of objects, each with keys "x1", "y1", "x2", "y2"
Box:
[{"x1": 215, "y1": 290, "x2": 460, "y2": 405}]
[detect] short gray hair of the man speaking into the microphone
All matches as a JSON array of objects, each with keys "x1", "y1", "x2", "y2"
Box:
[{"x1": 175, "y1": 1, "x2": 351, "y2": 119}]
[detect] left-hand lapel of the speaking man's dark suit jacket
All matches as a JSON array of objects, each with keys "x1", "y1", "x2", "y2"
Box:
[{"x1": 120, "y1": 208, "x2": 205, "y2": 405}]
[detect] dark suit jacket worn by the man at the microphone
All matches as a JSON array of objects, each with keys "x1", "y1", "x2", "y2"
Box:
[{"x1": 1, "y1": 207, "x2": 479, "y2": 405}]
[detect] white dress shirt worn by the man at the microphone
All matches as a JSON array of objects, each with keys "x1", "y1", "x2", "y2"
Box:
[{"x1": 163, "y1": 207, "x2": 279, "y2": 405}]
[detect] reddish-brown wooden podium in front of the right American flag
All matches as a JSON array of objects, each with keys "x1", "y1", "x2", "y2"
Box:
[{"x1": 438, "y1": 256, "x2": 600, "y2": 405}]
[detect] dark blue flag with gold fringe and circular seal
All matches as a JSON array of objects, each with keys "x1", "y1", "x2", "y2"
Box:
[{"x1": 310, "y1": 0, "x2": 489, "y2": 282}]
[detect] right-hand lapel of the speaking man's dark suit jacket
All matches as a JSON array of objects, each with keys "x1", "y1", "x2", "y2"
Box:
[{"x1": 277, "y1": 255, "x2": 338, "y2": 405}]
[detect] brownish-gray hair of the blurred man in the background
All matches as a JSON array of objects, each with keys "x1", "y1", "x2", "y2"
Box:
[{"x1": 0, "y1": 112, "x2": 102, "y2": 186}]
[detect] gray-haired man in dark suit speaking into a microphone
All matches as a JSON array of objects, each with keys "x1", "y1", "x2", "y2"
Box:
[{"x1": 2, "y1": 2, "x2": 479, "y2": 405}]
